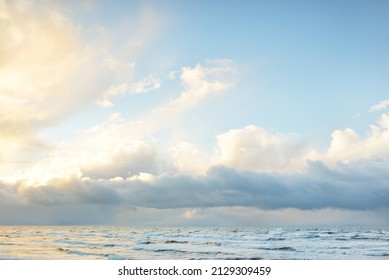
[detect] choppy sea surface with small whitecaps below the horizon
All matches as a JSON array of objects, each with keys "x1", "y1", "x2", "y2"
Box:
[{"x1": 0, "y1": 226, "x2": 389, "y2": 260}]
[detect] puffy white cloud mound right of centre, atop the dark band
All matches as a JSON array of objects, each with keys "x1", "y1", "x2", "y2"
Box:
[{"x1": 217, "y1": 125, "x2": 313, "y2": 173}]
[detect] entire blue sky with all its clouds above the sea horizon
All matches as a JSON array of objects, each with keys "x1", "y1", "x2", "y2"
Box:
[{"x1": 0, "y1": 0, "x2": 389, "y2": 226}]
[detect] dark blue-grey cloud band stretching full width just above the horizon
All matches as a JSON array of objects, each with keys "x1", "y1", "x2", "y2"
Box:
[{"x1": 0, "y1": 159, "x2": 389, "y2": 223}]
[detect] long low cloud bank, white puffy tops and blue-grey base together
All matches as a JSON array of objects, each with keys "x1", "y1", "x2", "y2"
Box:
[{"x1": 0, "y1": 110, "x2": 389, "y2": 224}]
